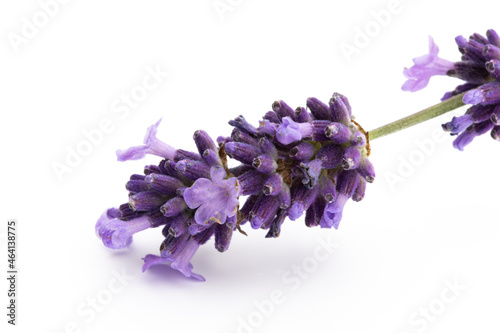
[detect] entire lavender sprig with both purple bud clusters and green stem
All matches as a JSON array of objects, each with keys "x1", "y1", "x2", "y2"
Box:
[{"x1": 96, "y1": 30, "x2": 500, "y2": 281}]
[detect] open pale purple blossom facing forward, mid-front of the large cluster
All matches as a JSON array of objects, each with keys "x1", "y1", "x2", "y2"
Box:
[{"x1": 183, "y1": 166, "x2": 240, "y2": 224}]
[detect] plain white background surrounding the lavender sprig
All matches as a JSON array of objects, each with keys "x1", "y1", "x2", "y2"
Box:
[{"x1": 0, "y1": 0, "x2": 500, "y2": 333}]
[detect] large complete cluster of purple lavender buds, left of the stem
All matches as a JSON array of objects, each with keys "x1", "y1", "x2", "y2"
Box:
[{"x1": 96, "y1": 93, "x2": 375, "y2": 280}]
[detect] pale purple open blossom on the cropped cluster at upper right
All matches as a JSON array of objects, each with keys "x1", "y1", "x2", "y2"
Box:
[{"x1": 401, "y1": 36, "x2": 453, "y2": 92}]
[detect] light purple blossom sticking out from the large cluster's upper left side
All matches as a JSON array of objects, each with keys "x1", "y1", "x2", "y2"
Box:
[{"x1": 116, "y1": 119, "x2": 176, "y2": 161}]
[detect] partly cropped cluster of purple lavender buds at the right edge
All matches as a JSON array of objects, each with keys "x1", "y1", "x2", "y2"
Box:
[{"x1": 402, "y1": 29, "x2": 500, "y2": 150}]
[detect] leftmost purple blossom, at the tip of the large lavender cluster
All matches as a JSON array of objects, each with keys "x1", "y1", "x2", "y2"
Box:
[{"x1": 95, "y1": 208, "x2": 151, "y2": 249}]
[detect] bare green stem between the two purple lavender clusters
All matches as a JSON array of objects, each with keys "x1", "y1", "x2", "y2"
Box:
[{"x1": 368, "y1": 93, "x2": 465, "y2": 141}]
